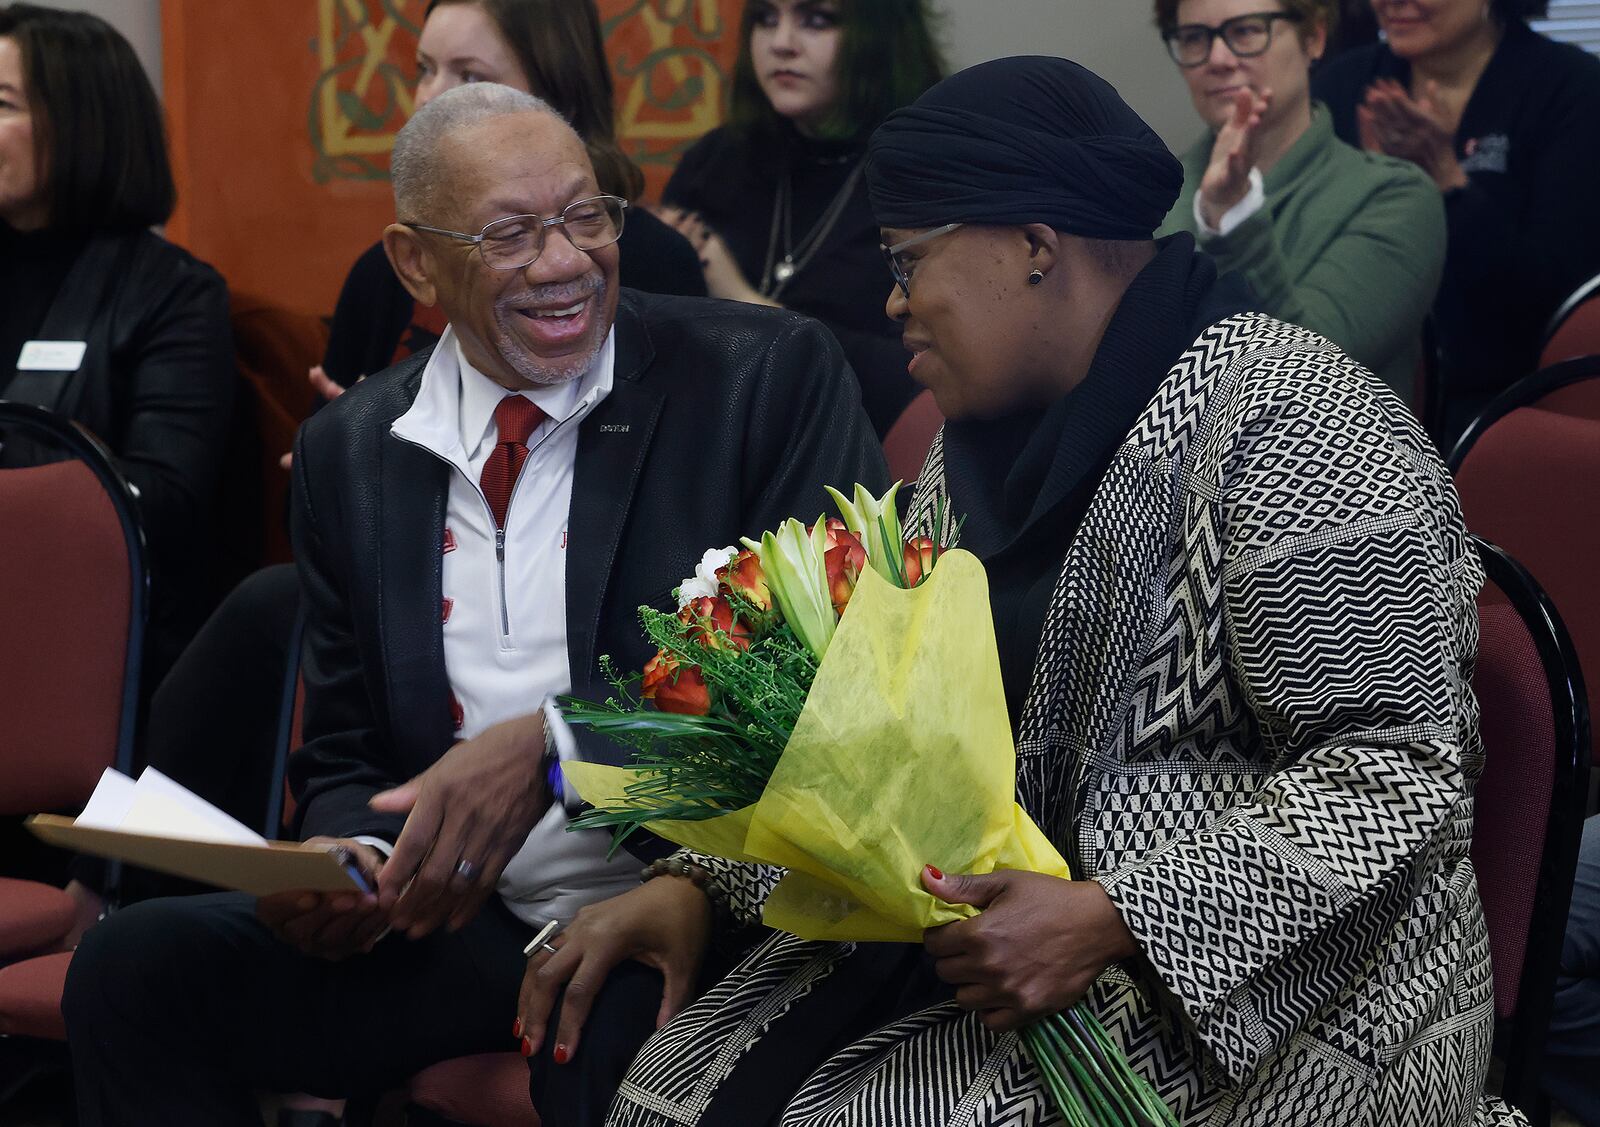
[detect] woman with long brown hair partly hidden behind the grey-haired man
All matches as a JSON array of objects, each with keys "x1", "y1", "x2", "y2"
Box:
[{"x1": 312, "y1": 0, "x2": 706, "y2": 395}]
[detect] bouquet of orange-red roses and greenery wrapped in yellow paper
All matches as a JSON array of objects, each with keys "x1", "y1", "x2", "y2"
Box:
[{"x1": 563, "y1": 485, "x2": 1176, "y2": 1127}]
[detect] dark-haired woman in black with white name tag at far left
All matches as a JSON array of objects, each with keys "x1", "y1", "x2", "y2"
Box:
[{"x1": 0, "y1": 3, "x2": 237, "y2": 685}]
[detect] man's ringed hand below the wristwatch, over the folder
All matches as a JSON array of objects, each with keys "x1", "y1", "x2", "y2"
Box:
[{"x1": 370, "y1": 712, "x2": 549, "y2": 940}]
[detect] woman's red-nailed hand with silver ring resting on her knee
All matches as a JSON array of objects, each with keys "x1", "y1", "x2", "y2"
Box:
[{"x1": 517, "y1": 876, "x2": 712, "y2": 1065}]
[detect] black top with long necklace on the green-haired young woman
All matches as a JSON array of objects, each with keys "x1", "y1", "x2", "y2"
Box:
[{"x1": 662, "y1": 126, "x2": 920, "y2": 435}]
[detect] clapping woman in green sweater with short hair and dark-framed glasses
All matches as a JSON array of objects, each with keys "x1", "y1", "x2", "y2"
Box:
[{"x1": 1155, "y1": 0, "x2": 1445, "y2": 402}]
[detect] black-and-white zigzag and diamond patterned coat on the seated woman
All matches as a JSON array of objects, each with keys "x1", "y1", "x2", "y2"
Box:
[{"x1": 610, "y1": 315, "x2": 1525, "y2": 1127}]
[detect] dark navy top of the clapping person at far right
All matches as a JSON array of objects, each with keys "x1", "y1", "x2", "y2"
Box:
[{"x1": 1314, "y1": 22, "x2": 1600, "y2": 448}]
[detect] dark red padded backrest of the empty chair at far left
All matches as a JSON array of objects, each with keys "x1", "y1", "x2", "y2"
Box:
[{"x1": 0, "y1": 402, "x2": 149, "y2": 813}]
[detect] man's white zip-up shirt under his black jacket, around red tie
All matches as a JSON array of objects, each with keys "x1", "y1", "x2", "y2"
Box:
[{"x1": 390, "y1": 328, "x2": 638, "y2": 924}]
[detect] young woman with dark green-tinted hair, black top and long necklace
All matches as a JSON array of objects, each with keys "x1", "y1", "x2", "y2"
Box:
[{"x1": 662, "y1": 0, "x2": 942, "y2": 435}]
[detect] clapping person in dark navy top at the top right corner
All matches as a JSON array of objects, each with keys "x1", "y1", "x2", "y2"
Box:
[{"x1": 1314, "y1": 0, "x2": 1600, "y2": 450}]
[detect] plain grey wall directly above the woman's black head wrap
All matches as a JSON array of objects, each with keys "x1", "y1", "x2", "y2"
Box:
[{"x1": 934, "y1": 0, "x2": 1200, "y2": 149}]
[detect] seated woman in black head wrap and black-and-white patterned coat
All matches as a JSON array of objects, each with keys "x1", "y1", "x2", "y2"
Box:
[{"x1": 525, "y1": 58, "x2": 1518, "y2": 1127}]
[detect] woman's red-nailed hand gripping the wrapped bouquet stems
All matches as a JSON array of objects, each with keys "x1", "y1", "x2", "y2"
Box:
[{"x1": 922, "y1": 869, "x2": 1138, "y2": 1033}]
